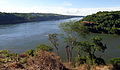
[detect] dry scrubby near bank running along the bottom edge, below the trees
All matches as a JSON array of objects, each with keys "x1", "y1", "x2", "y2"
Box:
[{"x1": 0, "y1": 50, "x2": 116, "y2": 70}]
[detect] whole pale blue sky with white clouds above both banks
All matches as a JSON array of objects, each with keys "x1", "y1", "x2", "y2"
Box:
[{"x1": 0, "y1": 0, "x2": 120, "y2": 16}]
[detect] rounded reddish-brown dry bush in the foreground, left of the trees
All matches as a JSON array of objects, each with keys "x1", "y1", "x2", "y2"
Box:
[{"x1": 26, "y1": 51, "x2": 67, "y2": 70}]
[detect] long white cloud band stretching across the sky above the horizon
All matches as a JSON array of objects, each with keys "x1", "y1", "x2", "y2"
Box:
[{"x1": 0, "y1": 6, "x2": 120, "y2": 16}]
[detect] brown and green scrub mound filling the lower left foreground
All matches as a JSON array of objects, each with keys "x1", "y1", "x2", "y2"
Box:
[{"x1": 0, "y1": 50, "x2": 68, "y2": 70}]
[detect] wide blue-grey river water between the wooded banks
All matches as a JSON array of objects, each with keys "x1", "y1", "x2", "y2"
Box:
[{"x1": 0, "y1": 18, "x2": 120, "y2": 60}]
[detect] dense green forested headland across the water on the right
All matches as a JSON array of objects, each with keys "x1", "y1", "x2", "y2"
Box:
[{"x1": 73, "y1": 11, "x2": 120, "y2": 34}]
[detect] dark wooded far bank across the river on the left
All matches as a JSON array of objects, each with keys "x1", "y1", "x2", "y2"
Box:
[{"x1": 0, "y1": 12, "x2": 80, "y2": 24}]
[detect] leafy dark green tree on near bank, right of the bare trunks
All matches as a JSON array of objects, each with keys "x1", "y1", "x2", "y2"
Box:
[{"x1": 75, "y1": 36, "x2": 107, "y2": 64}]
